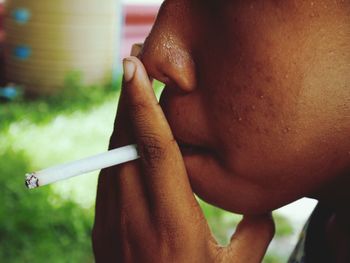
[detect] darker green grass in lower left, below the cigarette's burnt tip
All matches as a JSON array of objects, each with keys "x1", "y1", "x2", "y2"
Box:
[{"x1": 0, "y1": 149, "x2": 92, "y2": 263}]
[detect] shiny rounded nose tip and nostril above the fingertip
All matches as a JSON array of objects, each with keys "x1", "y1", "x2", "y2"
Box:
[{"x1": 140, "y1": 32, "x2": 196, "y2": 92}]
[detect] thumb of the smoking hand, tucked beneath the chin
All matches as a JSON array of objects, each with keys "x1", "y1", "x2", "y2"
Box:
[{"x1": 225, "y1": 214, "x2": 275, "y2": 263}]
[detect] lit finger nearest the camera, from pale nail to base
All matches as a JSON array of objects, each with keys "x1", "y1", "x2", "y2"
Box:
[{"x1": 124, "y1": 57, "x2": 195, "y2": 216}]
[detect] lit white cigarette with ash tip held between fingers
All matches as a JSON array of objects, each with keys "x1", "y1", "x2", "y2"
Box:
[{"x1": 25, "y1": 144, "x2": 139, "y2": 189}]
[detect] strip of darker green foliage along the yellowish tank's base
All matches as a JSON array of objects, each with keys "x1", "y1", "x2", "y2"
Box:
[{"x1": 0, "y1": 72, "x2": 120, "y2": 131}]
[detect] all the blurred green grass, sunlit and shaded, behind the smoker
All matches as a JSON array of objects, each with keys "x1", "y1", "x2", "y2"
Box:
[{"x1": 0, "y1": 77, "x2": 292, "y2": 263}]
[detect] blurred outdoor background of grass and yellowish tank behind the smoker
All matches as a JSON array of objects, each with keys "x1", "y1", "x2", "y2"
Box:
[{"x1": 0, "y1": 0, "x2": 315, "y2": 263}]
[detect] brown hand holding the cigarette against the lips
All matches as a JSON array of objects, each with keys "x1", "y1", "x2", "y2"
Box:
[{"x1": 93, "y1": 57, "x2": 274, "y2": 263}]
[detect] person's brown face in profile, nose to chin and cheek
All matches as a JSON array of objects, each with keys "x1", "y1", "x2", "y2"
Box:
[{"x1": 141, "y1": 0, "x2": 350, "y2": 214}]
